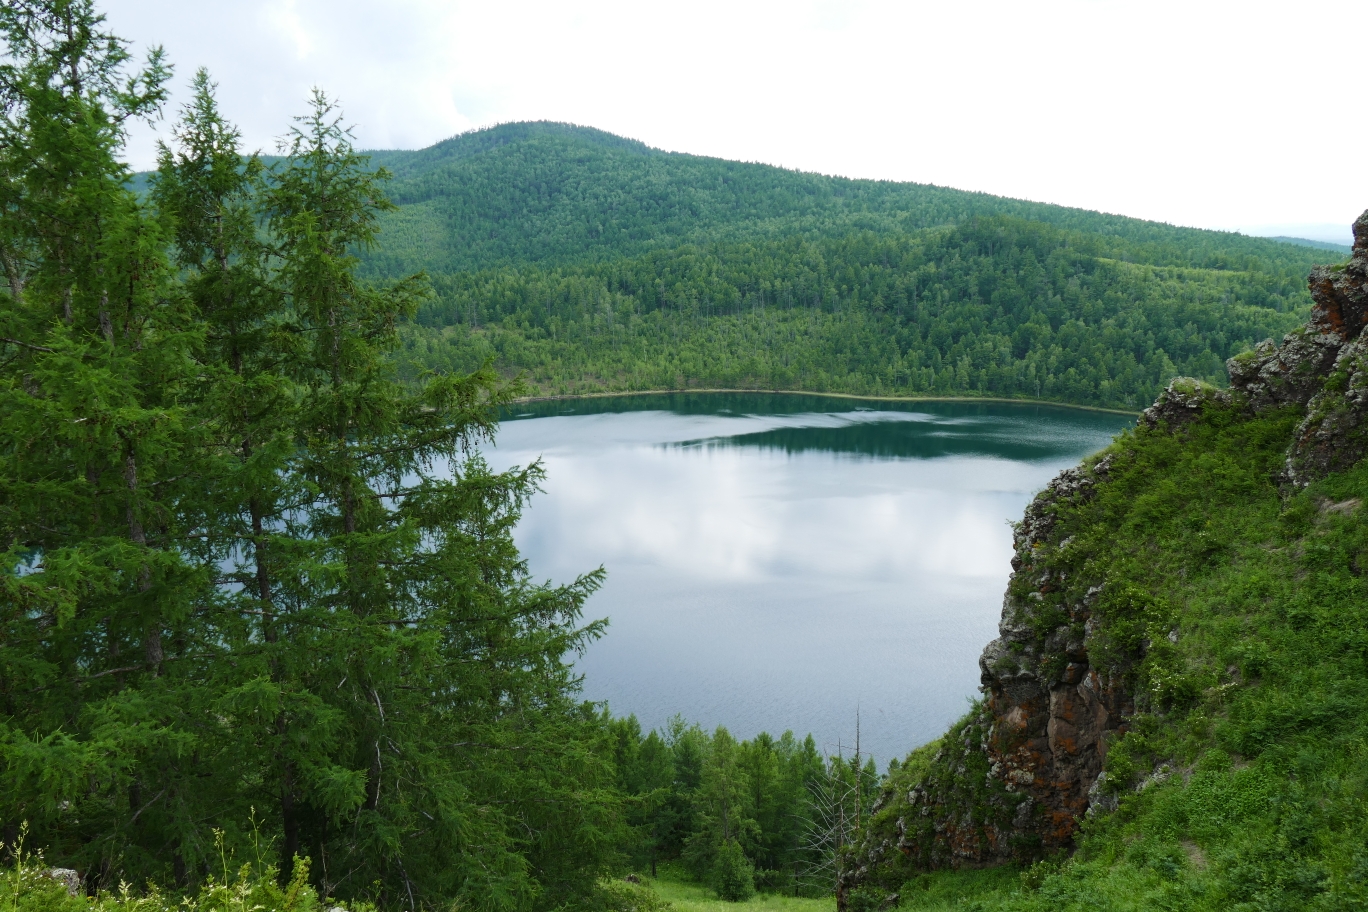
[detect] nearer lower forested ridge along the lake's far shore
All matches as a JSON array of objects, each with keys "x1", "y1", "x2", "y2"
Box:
[{"x1": 404, "y1": 216, "x2": 1309, "y2": 409}]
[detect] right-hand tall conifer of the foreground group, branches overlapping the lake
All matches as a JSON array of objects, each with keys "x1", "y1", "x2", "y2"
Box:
[{"x1": 251, "y1": 94, "x2": 616, "y2": 908}]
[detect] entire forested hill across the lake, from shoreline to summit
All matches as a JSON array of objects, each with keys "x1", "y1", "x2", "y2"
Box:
[{"x1": 328, "y1": 123, "x2": 1327, "y2": 410}]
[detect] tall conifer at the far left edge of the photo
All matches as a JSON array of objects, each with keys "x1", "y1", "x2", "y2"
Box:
[{"x1": 0, "y1": 0, "x2": 224, "y2": 881}]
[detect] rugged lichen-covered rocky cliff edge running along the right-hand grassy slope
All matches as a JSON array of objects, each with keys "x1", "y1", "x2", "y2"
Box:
[{"x1": 837, "y1": 212, "x2": 1368, "y2": 908}]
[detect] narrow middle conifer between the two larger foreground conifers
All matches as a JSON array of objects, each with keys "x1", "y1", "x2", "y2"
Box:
[{"x1": 150, "y1": 70, "x2": 304, "y2": 882}]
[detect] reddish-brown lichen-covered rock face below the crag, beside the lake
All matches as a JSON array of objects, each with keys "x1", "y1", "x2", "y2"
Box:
[{"x1": 841, "y1": 458, "x2": 1134, "y2": 891}]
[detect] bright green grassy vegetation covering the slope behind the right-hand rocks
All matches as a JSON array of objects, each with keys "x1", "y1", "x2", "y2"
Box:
[{"x1": 853, "y1": 347, "x2": 1368, "y2": 911}]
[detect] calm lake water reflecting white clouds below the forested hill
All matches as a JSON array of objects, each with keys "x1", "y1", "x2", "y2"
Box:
[{"x1": 486, "y1": 394, "x2": 1133, "y2": 766}]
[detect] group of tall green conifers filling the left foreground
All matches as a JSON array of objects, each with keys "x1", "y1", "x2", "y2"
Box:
[{"x1": 0, "y1": 0, "x2": 622, "y2": 909}]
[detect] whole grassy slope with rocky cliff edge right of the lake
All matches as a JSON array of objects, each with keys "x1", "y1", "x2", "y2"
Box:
[{"x1": 843, "y1": 222, "x2": 1368, "y2": 912}]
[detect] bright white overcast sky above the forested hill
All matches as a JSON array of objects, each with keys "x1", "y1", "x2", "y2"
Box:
[{"x1": 101, "y1": 0, "x2": 1368, "y2": 242}]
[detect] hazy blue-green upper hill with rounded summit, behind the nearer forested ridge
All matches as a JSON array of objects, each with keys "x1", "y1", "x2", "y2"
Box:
[{"x1": 367, "y1": 122, "x2": 1340, "y2": 275}]
